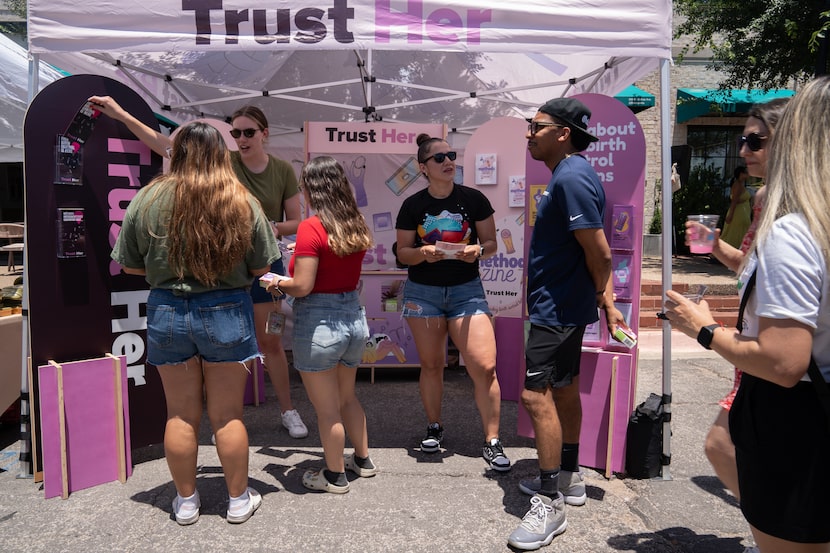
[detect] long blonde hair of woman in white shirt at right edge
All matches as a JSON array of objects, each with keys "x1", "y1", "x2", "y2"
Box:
[{"x1": 753, "y1": 76, "x2": 830, "y2": 268}]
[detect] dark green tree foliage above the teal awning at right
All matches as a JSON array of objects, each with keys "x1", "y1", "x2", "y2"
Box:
[{"x1": 674, "y1": 0, "x2": 830, "y2": 89}]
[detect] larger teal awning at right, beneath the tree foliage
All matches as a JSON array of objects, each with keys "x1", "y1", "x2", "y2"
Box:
[{"x1": 677, "y1": 88, "x2": 795, "y2": 123}]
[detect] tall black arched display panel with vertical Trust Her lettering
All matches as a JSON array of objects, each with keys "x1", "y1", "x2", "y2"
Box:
[{"x1": 23, "y1": 75, "x2": 166, "y2": 462}]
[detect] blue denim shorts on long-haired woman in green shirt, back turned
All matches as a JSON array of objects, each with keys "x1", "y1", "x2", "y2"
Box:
[{"x1": 147, "y1": 288, "x2": 259, "y2": 366}]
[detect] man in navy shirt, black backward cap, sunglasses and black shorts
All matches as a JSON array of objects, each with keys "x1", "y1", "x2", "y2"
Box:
[{"x1": 508, "y1": 98, "x2": 625, "y2": 550}]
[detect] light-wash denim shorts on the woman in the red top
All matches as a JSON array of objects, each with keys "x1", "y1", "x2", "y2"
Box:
[{"x1": 292, "y1": 291, "x2": 369, "y2": 372}]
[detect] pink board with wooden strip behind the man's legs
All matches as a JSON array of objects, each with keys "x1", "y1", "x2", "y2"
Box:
[{"x1": 518, "y1": 351, "x2": 634, "y2": 472}]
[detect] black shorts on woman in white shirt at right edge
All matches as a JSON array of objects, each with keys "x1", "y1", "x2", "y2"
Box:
[{"x1": 729, "y1": 373, "x2": 830, "y2": 543}]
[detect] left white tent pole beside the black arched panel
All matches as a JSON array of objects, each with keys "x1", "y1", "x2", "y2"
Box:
[{"x1": 17, "y1": 54, "x2": 40, "y2": 478}]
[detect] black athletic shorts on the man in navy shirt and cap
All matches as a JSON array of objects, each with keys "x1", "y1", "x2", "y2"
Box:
[{"x1": 525, "y1": 323, "x2": 585, "y2": 390}]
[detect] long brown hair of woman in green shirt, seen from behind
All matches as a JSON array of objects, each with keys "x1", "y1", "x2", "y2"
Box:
[{"x1": 149, "y1": 122, "x2": 253, "y2": 286}]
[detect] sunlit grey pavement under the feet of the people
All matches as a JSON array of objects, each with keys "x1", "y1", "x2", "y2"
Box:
[{"x1": 0, "y1": 331, "x2": 750, "y2": 553}]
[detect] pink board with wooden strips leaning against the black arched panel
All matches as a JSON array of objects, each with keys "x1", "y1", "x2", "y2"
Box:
[{"x1": 38, "y1": 357, "x2": 132, "y2": 499}]
